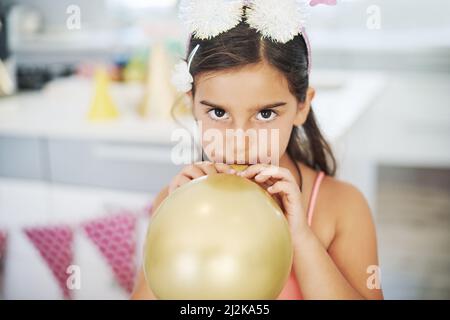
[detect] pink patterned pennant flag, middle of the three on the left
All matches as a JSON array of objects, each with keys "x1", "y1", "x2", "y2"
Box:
[{"x1": 25, "y1": 226, "x2": 73, "y2": 299}]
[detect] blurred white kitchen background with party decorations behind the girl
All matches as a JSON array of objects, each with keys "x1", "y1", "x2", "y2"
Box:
[{"x1": 0, "y1": 0, "x2": 450, "y2": 299}]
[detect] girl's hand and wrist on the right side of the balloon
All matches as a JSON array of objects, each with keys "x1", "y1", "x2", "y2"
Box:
[{"x1": 237, "y1": 164, "x2": 308, "y2": 239}]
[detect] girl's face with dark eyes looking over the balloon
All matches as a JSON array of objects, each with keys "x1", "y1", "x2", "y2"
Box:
[{"x1": 189, "y1": 62, "x2": 314, "y2": 164}]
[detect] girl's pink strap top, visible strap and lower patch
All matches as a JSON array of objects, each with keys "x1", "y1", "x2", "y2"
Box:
[{"x1": 277, "y1": 171, "x2": 325, "y2": 300}]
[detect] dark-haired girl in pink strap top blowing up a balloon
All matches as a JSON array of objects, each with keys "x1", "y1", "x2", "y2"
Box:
[{"x1": 132, "y1": 6, "x2": 383, "y2": 299}]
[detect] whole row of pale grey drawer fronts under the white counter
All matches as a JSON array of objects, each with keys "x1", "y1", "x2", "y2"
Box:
[{"x1": 0, "y1": 136, "x2": 180, "y2": 193}]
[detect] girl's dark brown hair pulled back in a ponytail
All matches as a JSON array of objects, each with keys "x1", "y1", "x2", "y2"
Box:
[{"x1": 178, "y1": 18, "x2": 336, "y2": 176}]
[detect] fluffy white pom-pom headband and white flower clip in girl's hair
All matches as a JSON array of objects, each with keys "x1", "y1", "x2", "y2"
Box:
[{"x1": 172, "y1": 0, "x2": 311, "y2": 93}]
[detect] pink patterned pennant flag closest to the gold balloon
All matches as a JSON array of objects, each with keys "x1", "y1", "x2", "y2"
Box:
[{"x1": 83, "y1": 213, "x2": 136, "y2": 293}]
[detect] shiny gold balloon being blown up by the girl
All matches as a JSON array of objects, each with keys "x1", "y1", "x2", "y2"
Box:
[{"x1": 144, "y1": 173, "x2": 293, "y2": 299}]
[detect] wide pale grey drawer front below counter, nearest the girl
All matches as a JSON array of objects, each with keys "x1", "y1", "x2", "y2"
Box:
[{"x1": 48, "y1": 140, "x2": 180, "y2": 193}]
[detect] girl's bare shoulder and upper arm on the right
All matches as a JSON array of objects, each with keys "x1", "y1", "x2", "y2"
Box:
[{"x1": 318, "y1": 177, "x2": 383, "y2": 299}]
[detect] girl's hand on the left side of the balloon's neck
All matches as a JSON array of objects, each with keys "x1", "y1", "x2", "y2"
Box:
[{"x1": 169, "y1": 161, "x2": 236, "y2": 194}]
